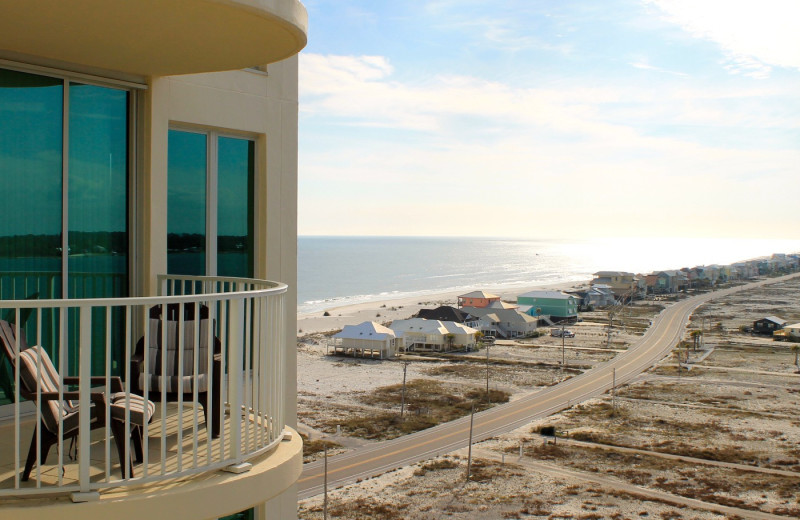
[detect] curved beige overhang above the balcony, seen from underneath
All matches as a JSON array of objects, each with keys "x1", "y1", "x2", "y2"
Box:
[{"x1": 0, "y1": 0, "x2": 308, "y2": 76}]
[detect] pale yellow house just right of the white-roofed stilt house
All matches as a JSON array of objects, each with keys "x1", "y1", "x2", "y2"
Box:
[{"x1": 389, "y1": 318, "x2": 478, "y2": 352}]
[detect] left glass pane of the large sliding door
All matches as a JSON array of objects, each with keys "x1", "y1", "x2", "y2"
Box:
[{"x1": 0, "y1": 69, "x2": 64, "y2": 404}]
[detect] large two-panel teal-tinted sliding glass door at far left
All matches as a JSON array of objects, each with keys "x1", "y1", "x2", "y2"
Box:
[{"x1": 0, "y1": 69, "x2": 130, "y2": 403}]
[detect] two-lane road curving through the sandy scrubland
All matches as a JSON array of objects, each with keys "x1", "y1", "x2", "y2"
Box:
[{"x1": 298, "y1": 274, "x2": 798, "y2": 499}]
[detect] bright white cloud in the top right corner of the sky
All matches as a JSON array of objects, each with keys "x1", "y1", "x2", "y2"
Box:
[{"x1": 646, "y1": 0, "x2": 800, "y2": 78}]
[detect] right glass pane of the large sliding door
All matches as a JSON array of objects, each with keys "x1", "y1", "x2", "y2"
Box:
[{"x1": 67, "y1": 83, "x2": 129, "y2": 374}]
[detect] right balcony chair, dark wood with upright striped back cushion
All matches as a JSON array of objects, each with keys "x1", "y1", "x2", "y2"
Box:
[{"x1": 131, "y1": 303, "x2": 222, "y2": 438}]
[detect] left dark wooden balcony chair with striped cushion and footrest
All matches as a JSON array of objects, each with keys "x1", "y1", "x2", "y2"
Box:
[{"x1": 0, "y1": 320, "x2": 155, "y2": 481}]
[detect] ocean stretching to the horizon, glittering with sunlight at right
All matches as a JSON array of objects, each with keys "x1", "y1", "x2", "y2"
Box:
[{"x1": 297, "y1": 236, "x2": 800, "y2": 314}]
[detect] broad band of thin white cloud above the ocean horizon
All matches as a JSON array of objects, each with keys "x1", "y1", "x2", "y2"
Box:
[{"x1": 300, "y1": 54, "x2": 800, "y2": 236}]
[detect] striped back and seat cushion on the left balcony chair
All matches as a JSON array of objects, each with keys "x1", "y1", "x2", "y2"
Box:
[{"x1": 18, "y1": 345, "x2": 78, "y2": 434}]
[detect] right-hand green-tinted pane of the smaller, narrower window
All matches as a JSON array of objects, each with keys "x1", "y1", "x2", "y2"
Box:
[{"x1": 217, "y1": 137, "x2": 255, "y2": 278}]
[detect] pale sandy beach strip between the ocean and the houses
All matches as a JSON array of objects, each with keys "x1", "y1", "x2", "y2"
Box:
[{"x1": 297, "y1": 279, "x2": 590, "y2": 337}]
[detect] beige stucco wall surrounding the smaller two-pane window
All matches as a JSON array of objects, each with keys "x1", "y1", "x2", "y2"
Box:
[{"x1": 135, "y1": 57, "x2": 298, "y2": 520}]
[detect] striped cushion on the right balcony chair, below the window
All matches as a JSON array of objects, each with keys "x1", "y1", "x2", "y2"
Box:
[{"x1": 139, "y1": 319, "x2": 209, "y2": 393}]
